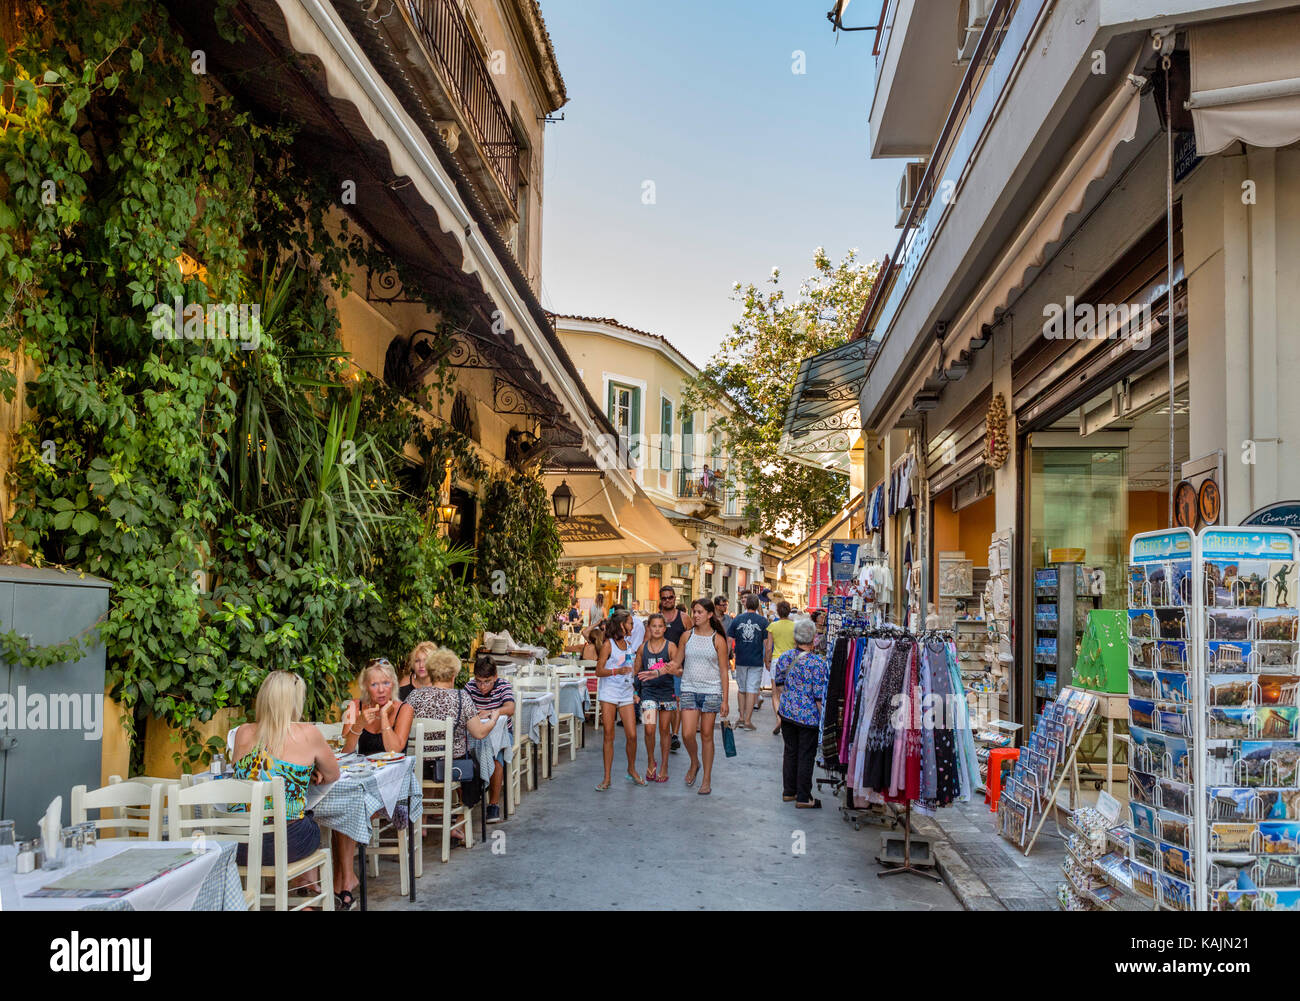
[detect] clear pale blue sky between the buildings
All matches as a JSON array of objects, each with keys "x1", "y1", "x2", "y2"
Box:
[{"x1": 542, "y1": 0, "x2": 902, "y2": 364}]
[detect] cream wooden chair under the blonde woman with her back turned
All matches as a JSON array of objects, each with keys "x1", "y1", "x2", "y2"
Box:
[{"x1": 168, "y1": 775, "x2": 334, "y2": 911}]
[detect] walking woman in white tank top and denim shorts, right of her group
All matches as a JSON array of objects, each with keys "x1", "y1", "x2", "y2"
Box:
[{"x1": 672, "y1": 598, "x2": 728, "y2": 796}]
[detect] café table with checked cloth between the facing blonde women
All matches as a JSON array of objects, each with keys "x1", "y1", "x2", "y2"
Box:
[{"x1": 307, "y1": 754, "x2": 424, "y2": 910}]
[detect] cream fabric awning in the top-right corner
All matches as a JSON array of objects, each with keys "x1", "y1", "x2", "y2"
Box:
[{"x1": 1187, "y1": 10, "x2": 1300, "y2": 156}]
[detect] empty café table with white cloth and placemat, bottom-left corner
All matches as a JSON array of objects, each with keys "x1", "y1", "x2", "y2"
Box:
[{"x1": 0, "y1": 837, "x2": 248, "y2": 911}]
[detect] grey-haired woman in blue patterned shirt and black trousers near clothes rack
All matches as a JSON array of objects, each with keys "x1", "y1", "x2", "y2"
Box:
[{"x1": 772, "y1": 619, "x2": 831, "y2": 810}]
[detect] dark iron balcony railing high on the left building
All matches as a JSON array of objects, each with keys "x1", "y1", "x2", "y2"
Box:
[{"x1": 397, "y1": 0, "x2": 519, "y2": 211}]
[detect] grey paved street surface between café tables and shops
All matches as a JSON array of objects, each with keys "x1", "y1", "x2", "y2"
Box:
[{"x1": 371, "y1": 685, "x2": 961, "y2": 911}]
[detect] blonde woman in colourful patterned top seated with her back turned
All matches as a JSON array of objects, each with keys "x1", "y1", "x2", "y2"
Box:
[{"x1": 233, "y1": 671, "x2": 338, "y2": 887}]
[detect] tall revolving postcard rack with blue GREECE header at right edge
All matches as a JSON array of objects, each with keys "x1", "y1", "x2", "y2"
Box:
[{"x1": 1123, "y1": 528, "x2": 1300, "y2": 910}]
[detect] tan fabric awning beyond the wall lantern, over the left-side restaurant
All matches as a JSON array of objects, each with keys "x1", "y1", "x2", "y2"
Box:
[{"x1": 543, "y1": 472, "x2": 698, "y2": 563}]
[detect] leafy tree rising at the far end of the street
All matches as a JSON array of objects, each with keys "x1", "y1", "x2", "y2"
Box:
[{"x1": 686, "y1": 247, "x2": 879, "y2": 537}]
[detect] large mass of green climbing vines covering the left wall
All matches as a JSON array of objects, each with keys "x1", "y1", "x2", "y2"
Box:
[{"x1": 0, "y1": 0, "x2": 558, "y2": 764}]
